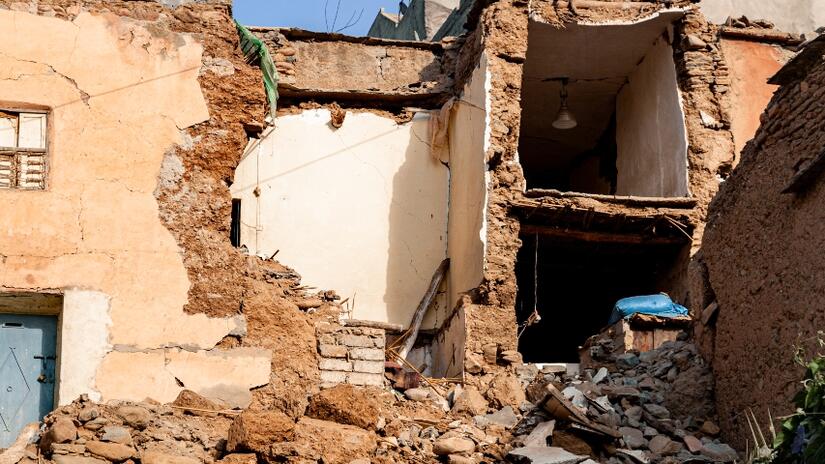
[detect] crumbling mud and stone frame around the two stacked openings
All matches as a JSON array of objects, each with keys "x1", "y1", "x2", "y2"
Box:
[{"x1": 460, "y1": 0, "x2": 734, "y2": 385}]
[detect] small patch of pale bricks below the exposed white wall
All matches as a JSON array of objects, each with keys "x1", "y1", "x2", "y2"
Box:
[{"x1": 316, "y1": 325, "x2": 386, "y2": 388}]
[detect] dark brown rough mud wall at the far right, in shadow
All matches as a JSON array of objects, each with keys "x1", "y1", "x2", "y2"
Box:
[{"x1": 702, "y1": 56, "x2": 825, "y2": 446}]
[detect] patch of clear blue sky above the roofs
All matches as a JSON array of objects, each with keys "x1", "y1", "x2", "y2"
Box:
[{"x1": 233, "y1": 0, "x2": 398, "y2": 35}]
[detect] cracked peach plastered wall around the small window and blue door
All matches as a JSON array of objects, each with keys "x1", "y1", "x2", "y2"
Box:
[{"x1": 0, "y1": 10, "x2": 269, "y2": 403}]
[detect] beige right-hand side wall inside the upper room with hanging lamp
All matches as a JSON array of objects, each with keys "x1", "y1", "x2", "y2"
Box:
[{"x1": 616, "y1": 38, "x2": 688, "y2": 197}]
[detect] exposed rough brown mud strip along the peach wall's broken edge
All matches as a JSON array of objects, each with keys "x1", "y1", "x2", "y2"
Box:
[{"x1": 2, "y1": 0, "x2": 332, "y2": 416}]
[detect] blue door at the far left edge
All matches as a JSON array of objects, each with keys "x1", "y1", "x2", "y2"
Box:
[{"x1": 0, "y1": 314, "x2": 57, "y2": 448}]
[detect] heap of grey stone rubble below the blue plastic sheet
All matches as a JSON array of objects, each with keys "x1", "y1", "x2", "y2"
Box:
[{"x1": 510, "y1": 338, "x2": 738, "y2": 464}]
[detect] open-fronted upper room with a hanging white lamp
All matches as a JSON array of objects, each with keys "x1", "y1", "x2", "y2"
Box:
[{"x1": 519, "y1": 10, "x2": 688, "y2": 197}]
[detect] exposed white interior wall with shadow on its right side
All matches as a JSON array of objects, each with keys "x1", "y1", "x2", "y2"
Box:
[{"x1": 231, "y1": 110, "x2": 449, "y2": 325}]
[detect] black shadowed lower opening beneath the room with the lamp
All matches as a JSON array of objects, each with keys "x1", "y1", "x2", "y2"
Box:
[{"x1": 516, "y1": 232, "x2": 684, "y2": 363}]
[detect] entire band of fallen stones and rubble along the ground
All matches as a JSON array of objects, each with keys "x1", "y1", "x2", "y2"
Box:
[{"x1": 21, "y1": 338, "x2": 739, "y2": 464}]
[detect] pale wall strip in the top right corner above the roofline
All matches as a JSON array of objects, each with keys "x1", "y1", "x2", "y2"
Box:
[{"x1": 699, "y1": 0, "x2": 825, "y2": 35}]
